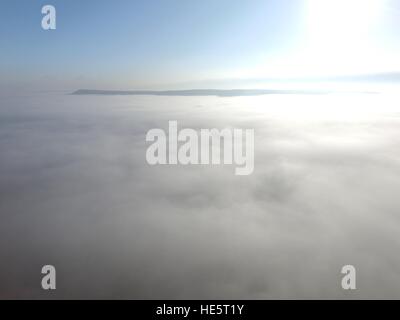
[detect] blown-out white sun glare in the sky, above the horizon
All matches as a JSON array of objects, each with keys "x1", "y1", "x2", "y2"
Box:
[{"x1": 260, "y1": 0, "x2": 393, "y2": 77}]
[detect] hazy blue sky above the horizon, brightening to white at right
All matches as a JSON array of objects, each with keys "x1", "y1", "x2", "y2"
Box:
[{"x1": 0, "y1": 0, "x2": 400, "y2": 90}]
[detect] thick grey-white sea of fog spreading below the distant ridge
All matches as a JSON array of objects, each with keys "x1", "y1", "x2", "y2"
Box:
[{"x1": 0, "y1": 92, "x2": 400, "y2": 299}]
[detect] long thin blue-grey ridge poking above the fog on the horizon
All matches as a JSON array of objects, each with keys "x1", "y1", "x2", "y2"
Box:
[{"x1": 72, "y1": 89, "x2": 331, "y2": 97}]
